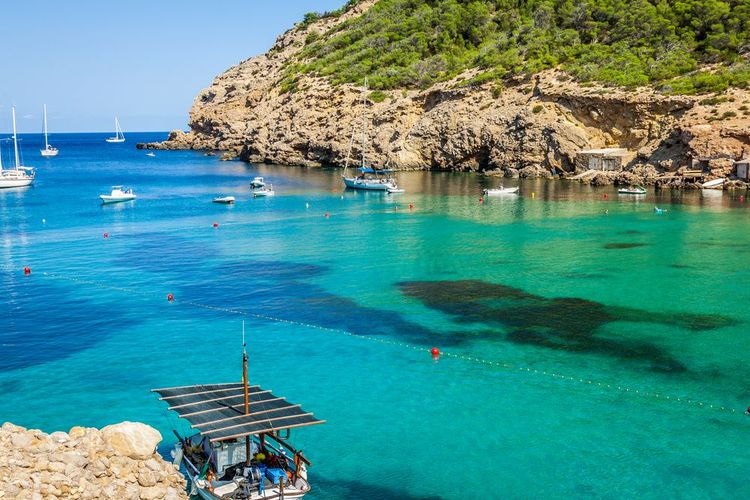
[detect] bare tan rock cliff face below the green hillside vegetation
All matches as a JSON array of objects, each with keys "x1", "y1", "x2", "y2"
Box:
[{"x1": 143, "y1": 0, "x2": 750, "y2": 186}]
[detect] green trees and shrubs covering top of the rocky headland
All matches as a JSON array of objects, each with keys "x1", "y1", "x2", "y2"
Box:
[{"x1": 290, "y1": 0, "x2": 750, "y2": 94}]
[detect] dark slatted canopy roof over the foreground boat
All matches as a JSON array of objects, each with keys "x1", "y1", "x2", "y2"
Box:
[{"x1": 152, "y1": 382, "x2": 325, "y2": 442}]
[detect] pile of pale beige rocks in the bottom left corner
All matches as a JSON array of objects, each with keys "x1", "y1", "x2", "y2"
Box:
[{"x1": 0, "y1": 422, "x2": 188, "y2": 500}]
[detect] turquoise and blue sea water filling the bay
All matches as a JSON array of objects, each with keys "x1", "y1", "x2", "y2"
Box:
[{"x1": 0, "y1": 134, "x2": 750, "y2": 499}]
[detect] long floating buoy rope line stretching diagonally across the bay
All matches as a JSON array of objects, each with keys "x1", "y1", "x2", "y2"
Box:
[{"x1": 4, "y1": 267, "x2": 743, "y2": 414}]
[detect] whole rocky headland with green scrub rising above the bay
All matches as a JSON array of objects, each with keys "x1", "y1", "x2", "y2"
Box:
[{"x1": 147, "y1": 0, "x2": 750, "y2": 184}]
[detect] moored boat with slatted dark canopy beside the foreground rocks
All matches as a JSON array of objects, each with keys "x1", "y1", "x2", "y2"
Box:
[{"x1": 153, "y1": 321, "x2": 324, "y2": 500}]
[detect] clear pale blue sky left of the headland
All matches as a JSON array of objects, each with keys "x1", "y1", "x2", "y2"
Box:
[{"x1": 0, "y1": 0, "x2": 345, "y2": 132}]
